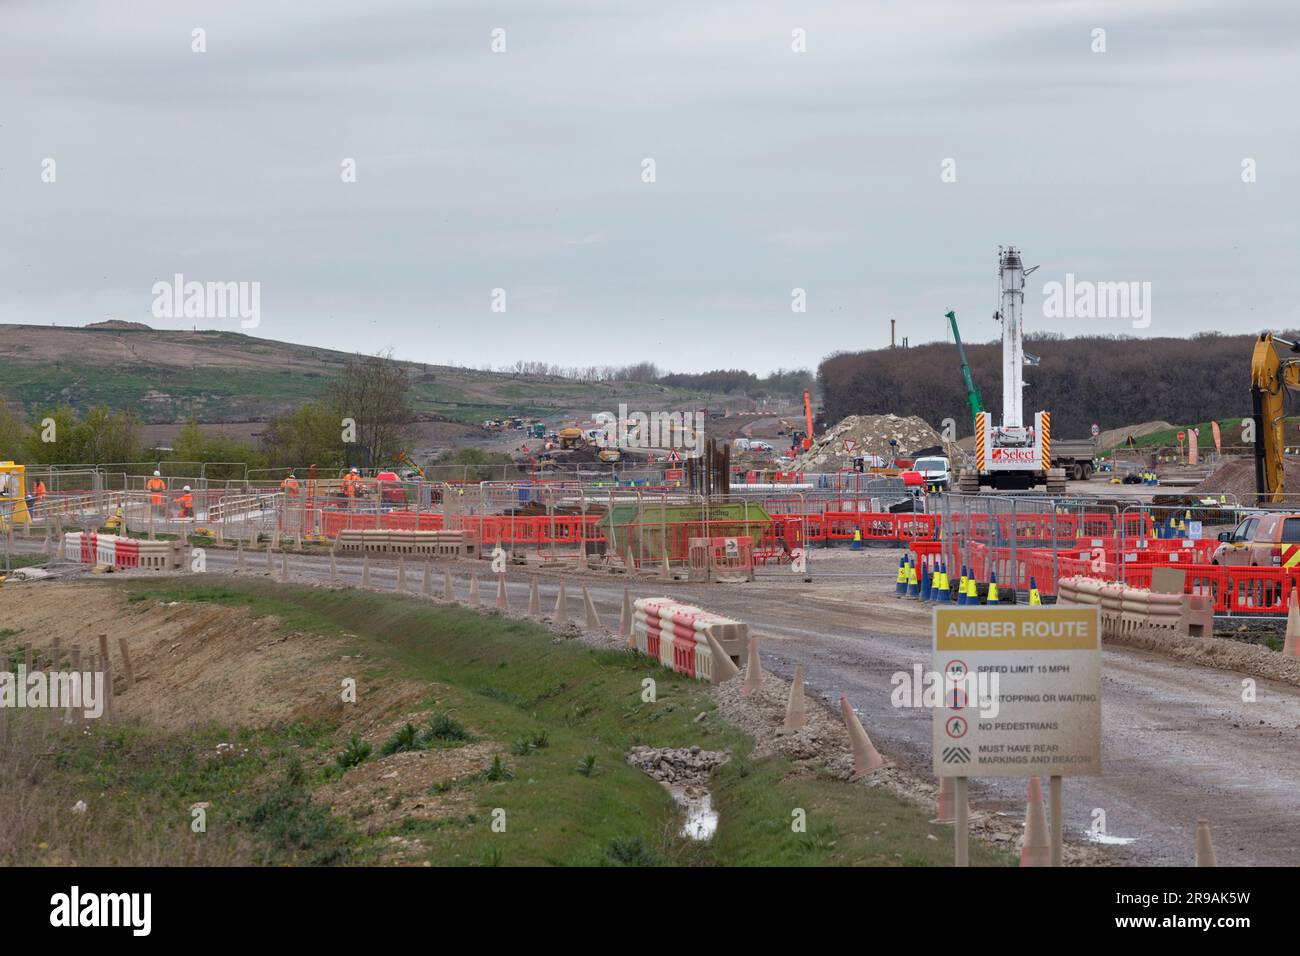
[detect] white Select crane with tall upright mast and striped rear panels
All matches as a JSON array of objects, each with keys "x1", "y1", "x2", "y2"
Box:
[{"x1": 953, "y1": 246, "x2": 1065, "y2": 494}]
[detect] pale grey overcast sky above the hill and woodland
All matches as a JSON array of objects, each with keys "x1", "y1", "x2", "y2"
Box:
[{"x1": 0, "y1": 0, "x2": 1300, "y2": 372}]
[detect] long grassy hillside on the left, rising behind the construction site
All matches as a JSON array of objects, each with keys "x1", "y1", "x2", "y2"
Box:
[{"x1": 0, "y1": 325, "x2": 709, "y2": 423}]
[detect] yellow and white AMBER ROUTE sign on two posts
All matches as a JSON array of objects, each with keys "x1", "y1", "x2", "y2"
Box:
[{"x1": 933, "y1": 605, "x2": 1101, "y2": 866}]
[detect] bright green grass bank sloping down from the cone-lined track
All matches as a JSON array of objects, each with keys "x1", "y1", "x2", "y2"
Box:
[{"x1": 65, "y1": 579, "x2": 1013, "y2": 866}]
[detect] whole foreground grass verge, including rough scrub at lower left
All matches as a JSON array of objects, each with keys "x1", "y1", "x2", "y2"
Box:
[{"x1": 0, "y1": 579, "x2": 1011, "y2": 866}]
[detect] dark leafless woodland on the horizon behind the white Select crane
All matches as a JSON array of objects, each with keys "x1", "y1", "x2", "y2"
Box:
[{"x1": 818, "y1": 333, "x2": 1274, "y2": 438}]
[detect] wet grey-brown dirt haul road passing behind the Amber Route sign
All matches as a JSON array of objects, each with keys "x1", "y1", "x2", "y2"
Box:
[{"x1": 10, "y1": 542, "x2": 1300, "y2": 866}]
